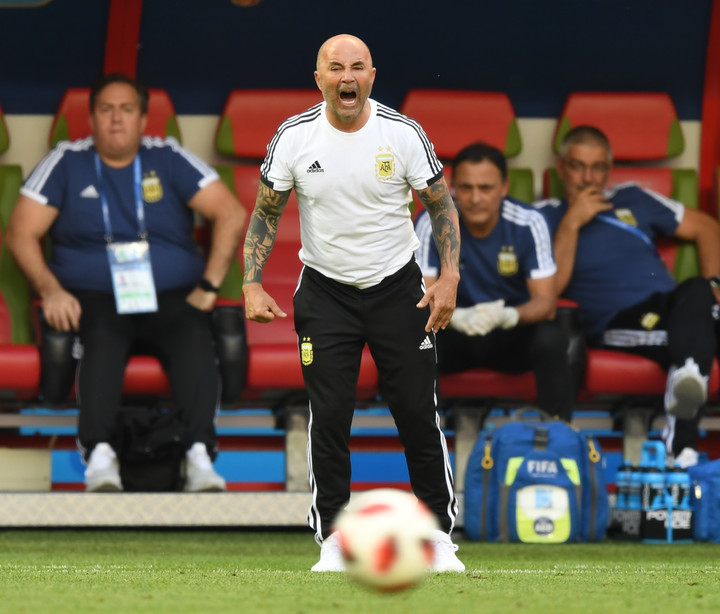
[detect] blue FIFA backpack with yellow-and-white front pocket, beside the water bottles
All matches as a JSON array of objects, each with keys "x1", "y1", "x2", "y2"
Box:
[{"x1": 465, "y1": 420, "x2": 609, "y2": 543}]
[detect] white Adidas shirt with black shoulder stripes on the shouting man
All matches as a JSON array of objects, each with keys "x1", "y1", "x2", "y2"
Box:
[{"x1": 260, "y1": 99, "x2": 442, "y2": 288}]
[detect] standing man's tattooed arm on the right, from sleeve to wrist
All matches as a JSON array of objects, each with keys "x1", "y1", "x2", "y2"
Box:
[{"x1": 418, "y1": 179, "x2": 460, "y2": 273}]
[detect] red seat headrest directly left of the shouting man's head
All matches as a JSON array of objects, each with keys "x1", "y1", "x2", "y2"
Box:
[{"x1": 215, "y1": 89, "x2": 322, "y2": 161}]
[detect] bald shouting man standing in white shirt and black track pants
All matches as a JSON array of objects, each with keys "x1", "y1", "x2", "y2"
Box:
[{"x1": 243, "y1": 34, "x2": 465, "y2": 572}]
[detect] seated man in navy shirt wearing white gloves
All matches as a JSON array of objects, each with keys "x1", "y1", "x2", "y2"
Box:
[{"x1": 415, "y1": 143, "x2": 575, "y2": 421}]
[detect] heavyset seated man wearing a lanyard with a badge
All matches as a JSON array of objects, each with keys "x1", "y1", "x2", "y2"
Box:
[{"x1": 6, "y1": 74, "x2": 245, "y2": 492}]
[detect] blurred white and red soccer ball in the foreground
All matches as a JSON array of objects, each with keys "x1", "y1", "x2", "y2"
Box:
[{"x1": 334, "y1": 488, "x2": 438, "y2": 591}]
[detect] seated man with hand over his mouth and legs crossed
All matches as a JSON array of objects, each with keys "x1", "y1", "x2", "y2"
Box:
[{"x1": 537, "y1": 126, "x2": 720, "y2": 466}]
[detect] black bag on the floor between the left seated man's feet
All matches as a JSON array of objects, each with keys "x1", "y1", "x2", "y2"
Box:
[{"x1": 118, "y1": 407, "x2": 188, "y2": 492}]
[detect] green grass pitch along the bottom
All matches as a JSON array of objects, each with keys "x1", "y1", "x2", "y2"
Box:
[{"x1": 0, "y1": 530, "x2": 720, "y2": 614}]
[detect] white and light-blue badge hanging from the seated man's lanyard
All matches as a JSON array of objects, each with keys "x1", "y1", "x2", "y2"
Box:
[{"x1": 107, "y1": 241, "x2": 157, "y2": 314}]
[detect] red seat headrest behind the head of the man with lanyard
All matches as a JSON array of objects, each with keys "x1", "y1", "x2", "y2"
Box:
[{"x1": 49, "y1": 87, "x2": 182, "y2": 147}]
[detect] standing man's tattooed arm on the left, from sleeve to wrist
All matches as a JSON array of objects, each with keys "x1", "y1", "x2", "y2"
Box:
[{"x1": 243, "y1": 182, "x2": 290, "y2": 283}]
